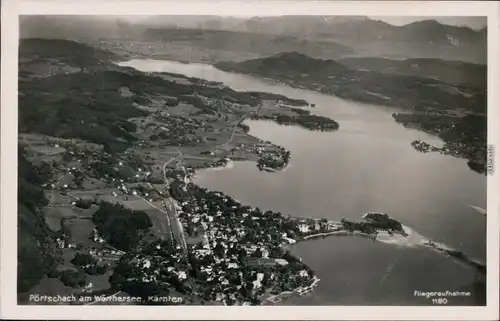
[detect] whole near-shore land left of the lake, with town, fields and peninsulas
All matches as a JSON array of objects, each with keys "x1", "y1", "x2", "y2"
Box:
[{"x1": 19, "y1": 37, "x2": 406, "y2": 305}]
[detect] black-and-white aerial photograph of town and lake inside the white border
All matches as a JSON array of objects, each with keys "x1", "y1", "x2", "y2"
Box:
[{"x1": 17, "y1": 15, "x2": 491, "y2": 306}]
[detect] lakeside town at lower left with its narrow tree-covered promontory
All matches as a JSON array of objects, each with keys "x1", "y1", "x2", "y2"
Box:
[{"x1": 20, "y1": 127, "x2": 406, "y2": 305}]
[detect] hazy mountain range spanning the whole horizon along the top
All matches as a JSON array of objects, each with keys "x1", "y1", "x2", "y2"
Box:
[{"x1": 21, "y1": 16, "x2": 487, "y2": 64}]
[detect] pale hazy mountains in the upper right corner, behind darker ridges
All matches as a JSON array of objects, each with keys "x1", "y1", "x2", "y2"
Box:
[{"x1": 258, "y1": 18, "x2": 487, "y2": 64}]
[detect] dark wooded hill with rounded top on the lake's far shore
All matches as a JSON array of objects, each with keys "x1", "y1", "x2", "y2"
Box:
[{"x1": 215, "y1": 52, "x2": 486, "y2": 112}]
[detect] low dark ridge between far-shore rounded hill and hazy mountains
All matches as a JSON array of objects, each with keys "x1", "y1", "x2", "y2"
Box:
[{"x1": 339, "y1": 57, "x2": 487, "y2": 88}]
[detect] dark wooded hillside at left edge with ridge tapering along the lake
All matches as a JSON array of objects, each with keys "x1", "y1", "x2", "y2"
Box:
[{"x1": 19, "y1": 39, "x2": 303, "y2": 151}]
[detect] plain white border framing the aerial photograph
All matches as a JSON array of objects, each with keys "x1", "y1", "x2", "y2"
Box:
[{"x1": 0, "y1": 0, "x2": 500, "y2": 320}]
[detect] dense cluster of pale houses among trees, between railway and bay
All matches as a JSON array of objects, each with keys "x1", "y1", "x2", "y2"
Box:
[{"x1": 164, "y1": 184, "x2": 314, "y2": 304}]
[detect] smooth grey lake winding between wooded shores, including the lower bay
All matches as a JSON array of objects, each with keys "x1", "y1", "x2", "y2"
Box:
[{"x1": 119, "y1": 59, "x2": 487, "y2": 305}]
